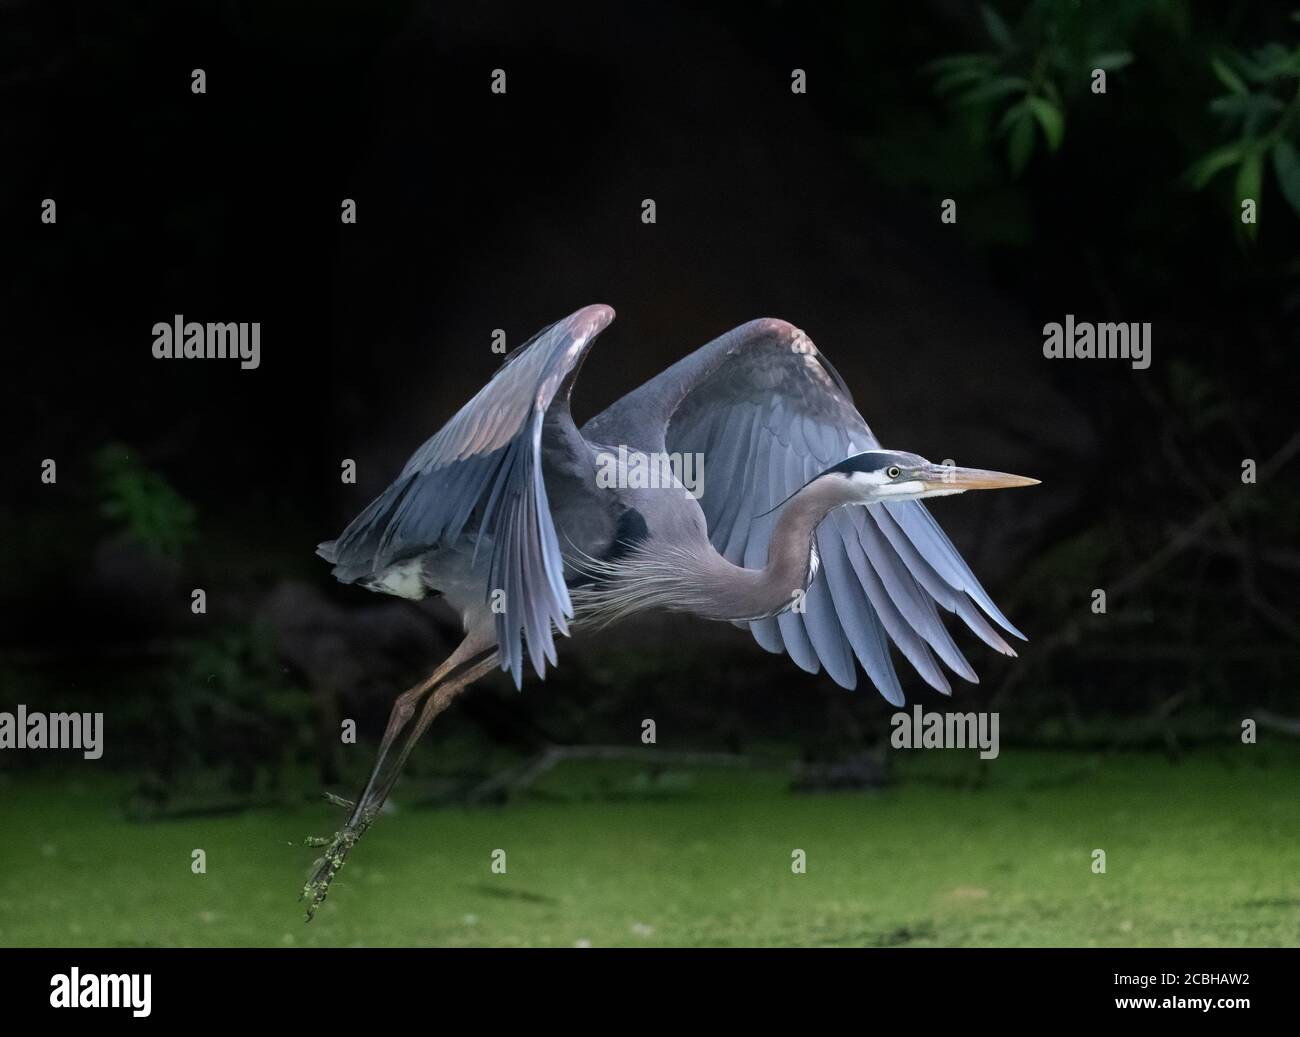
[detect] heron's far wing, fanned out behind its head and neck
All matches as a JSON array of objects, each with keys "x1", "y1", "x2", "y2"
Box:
[{"x1": 584, "y1": 320, "x2": 1024, "y2": 704}]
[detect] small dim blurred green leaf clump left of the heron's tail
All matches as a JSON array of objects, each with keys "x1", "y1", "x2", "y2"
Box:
[{"x1": 92, "y1": 443, "x2": 195, "y2": 557}]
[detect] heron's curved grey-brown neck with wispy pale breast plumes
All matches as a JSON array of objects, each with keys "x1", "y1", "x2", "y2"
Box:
[{"x1": 569, "y1": 481, "x2": 850, "y2": 625}]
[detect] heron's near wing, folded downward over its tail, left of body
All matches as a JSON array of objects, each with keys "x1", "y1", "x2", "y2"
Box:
[{"x1": 319, "y1": 305, "x2": 614, "y2": 685}]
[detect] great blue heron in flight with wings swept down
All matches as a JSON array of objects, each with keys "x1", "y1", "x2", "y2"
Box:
[{"x1": 303, "y1": 305, "x2": 1036, "y2": 917}]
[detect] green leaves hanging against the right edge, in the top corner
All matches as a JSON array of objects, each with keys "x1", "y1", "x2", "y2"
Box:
[{"x1": 1186, "y1": 35, "x2": 1300, "y2": 239}]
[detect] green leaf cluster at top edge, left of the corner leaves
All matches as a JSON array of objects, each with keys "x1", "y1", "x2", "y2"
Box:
[{"x1": 926, "y1": 0, "x2": 1132, "y2": 177}]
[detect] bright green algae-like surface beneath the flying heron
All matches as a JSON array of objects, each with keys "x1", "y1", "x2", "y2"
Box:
[{"x1": 0, "y1": 746, "x2": 1300, "y2": 947}]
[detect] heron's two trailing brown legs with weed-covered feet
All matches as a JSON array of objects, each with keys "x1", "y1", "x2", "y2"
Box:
[{"x1": 299, "y1": 638, "x2": 497, "y2": 921}]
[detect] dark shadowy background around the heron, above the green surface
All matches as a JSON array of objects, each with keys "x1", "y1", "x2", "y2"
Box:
[{"x1": 0, "y1": 1, "x2": 1300, "y2": 803}]
